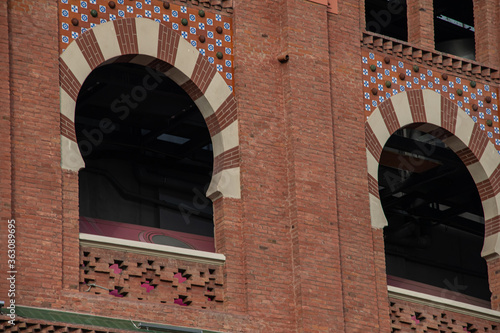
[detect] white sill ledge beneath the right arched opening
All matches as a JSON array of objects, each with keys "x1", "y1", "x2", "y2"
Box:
[{"x1": 387, "y1": 286, "x2": 500, "y2": 322}]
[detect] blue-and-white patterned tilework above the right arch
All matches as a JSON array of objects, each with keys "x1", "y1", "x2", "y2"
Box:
[{"x1": 361, "y1": 50, "x2": 500, "y2": 152}]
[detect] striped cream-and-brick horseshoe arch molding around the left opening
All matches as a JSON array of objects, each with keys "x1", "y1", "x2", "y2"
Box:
[{"x1": 59, "y1": 18, "x2": 241, "y2": 200}]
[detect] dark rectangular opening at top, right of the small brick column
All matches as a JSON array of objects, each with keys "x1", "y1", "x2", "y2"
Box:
[{"x1": 434, "y1": 0, "x2": 475, "y2": 60}]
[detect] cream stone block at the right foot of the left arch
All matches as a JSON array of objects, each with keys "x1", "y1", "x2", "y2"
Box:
[{"x1": 207, "y1": 167, "x2": 241, "y2": 201}]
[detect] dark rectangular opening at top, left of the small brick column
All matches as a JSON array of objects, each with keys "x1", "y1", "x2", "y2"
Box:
[{"x1": 365, "y1": 0, "x2": 408, "y2": 41}]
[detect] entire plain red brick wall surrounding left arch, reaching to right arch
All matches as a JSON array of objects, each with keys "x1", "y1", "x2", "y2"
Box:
[{"x1": 0, "y1": 0, "x2": 498, "y2": 332}]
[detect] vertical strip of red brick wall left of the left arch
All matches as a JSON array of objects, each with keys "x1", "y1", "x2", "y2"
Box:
[{"x1": 1, "y1": 0, "x2": 62, "y2": 306}]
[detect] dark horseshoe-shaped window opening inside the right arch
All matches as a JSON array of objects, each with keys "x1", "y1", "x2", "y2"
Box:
[{"x1": 379, "y1": 128, "x2": 491, "y2": 307}]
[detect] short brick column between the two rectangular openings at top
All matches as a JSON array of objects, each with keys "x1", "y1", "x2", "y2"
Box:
[{"x1": 407, "y1": 0, "x2": 434, "y2": 50}]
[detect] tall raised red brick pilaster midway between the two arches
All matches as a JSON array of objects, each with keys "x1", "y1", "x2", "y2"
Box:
[{"x1": 280, "y1": 1, "x2": 344, "y2": 332}]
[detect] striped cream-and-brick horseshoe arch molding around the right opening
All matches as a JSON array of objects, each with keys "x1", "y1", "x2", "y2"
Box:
[{"x1": 365, "y1": 89, "x2": 500, "y2": 259}]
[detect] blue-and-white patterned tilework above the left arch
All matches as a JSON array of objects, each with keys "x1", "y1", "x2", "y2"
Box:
[{"x1": 59, "y1": 0, "x2": 234, "y2": 91}]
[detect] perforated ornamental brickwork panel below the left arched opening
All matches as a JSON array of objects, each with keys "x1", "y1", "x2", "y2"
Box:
[{"x1": 80, "y1": 246, "x2": 223, "y2": 309}]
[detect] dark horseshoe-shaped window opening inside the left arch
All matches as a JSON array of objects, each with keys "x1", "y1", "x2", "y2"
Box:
[{"x1": 75, "y1": 63, "x2": 214, "y2": 251}]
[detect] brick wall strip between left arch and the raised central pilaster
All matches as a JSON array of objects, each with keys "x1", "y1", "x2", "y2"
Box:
[{"x1": 233, "y1": 0, "x2": 296, "y2": 326}]
